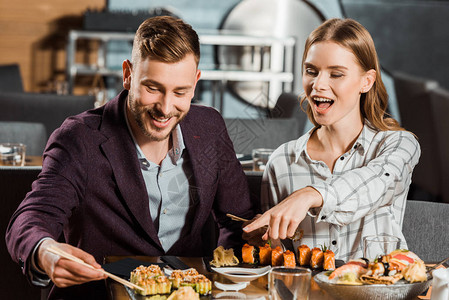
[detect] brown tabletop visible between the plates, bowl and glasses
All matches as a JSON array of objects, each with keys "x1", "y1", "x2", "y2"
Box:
[{"x1": 105, "y1": 256, "x2": 431, "y2": 300}]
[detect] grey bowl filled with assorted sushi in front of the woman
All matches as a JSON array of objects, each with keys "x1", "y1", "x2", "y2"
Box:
[{"x1": 314, "y1": 249, "x2": 432, "y2": 300}]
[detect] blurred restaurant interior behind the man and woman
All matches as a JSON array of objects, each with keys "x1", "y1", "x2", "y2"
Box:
[{"x1": 0, "y1": 0, "x2": 449, "y2": 299}]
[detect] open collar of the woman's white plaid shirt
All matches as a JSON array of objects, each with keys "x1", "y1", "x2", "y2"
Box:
[{"x1": 295, "y1": 119, "x2": 379, "y2": 162}]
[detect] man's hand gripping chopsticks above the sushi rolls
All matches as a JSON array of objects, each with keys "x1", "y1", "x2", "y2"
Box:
[{"x1": 37, "y1": 240, "x2": 107, "y2": 288}]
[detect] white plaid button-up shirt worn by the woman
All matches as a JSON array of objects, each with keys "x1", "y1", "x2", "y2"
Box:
[{"x1": 262, "y1": 121, "x2": 421, "y2": 261}]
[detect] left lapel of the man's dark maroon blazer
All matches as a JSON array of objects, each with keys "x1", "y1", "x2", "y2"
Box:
[{"x1": 101, "y1": 91, "x2": 163, "y2": 251}]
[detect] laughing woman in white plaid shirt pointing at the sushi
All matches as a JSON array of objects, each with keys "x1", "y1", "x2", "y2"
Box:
[{"x1": 244, "y1": 19, "x2": 420, "y2": 260}]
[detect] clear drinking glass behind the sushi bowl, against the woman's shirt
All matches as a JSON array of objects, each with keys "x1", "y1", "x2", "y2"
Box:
[{"x1": 363, "y1": 235, "x2": 401, "y2": 261}]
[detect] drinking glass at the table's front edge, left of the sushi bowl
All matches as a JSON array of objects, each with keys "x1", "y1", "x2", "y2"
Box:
[{"x1": 268, "y1": 267, "x2": 312, "y2": 300}]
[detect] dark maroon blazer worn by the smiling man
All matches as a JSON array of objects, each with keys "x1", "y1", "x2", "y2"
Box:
[{"x1": 6, "y1": 91, "x2": 253, "y2": 299}]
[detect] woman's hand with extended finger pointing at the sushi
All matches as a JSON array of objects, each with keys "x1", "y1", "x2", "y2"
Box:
[{"x1": 243, "y1": 187, "x2": 323, "y2": 240}]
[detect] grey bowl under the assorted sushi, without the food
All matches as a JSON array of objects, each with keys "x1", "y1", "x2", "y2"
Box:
[{"x1": 313, "y1": 271, "x2": 432, "y2": 300}]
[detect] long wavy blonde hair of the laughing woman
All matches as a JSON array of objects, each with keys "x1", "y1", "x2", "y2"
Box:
[{"x1": 300, "y1": 18, "x2": 405, "y2": 131}]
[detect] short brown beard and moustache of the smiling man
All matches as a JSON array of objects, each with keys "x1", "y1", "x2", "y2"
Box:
[{"x1": 128, "y1": 93, "x2": 186, "y2": 142}]
